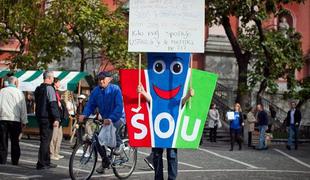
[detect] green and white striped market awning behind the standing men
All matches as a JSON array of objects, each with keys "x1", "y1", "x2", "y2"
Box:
[{"x1": 14, "y1": 71, "x2": 88, "y2": 91}]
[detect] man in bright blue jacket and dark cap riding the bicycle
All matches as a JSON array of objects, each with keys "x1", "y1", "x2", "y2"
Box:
[{"x1": 79, "y1": 72, "x2": 123, "y2": 173}]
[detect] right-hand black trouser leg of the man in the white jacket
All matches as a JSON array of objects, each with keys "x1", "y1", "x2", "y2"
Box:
[{"x1": 8, "y1": 122, "x2": 21, "y2": 165}]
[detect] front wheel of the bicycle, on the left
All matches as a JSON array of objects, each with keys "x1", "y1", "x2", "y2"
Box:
[{"x1": 69, "y1": 142, "x2": 97, "y2": 180}]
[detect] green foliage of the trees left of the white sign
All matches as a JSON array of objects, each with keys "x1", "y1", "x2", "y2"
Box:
[{"x1": 0, "y1": 0, "x2": 137, "y2": 70}]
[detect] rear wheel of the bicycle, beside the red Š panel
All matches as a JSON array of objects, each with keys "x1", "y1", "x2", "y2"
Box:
[{"x1": 111, "y1": 139, "x2": 137, "y2": 179}]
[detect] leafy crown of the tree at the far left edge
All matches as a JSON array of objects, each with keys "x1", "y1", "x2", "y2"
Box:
[{"x1": 0, "y1": 0, "x2": 66, "y2": 70}]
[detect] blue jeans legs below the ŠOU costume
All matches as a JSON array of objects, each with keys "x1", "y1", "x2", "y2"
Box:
[{"x1": 152, "y1": 148, "x2": 178, "y2": 180}]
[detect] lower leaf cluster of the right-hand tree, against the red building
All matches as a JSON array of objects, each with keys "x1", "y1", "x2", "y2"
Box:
[{"x1": 239, "y1": 26, "x2": 304, "y2": 93}]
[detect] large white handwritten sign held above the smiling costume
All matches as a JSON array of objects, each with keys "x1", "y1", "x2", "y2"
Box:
[{"x1": 128, "y1": 0, "x2": 205, "y2": 53}]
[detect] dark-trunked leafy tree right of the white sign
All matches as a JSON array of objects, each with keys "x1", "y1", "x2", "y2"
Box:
[{"x1": 206, "y1": 0, "x2": 303, "y2": 107}]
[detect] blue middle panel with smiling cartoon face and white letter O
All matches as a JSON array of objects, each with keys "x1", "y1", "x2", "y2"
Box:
[{"x1": 147, "y1": 53, "x2": 190, "y2": 147}]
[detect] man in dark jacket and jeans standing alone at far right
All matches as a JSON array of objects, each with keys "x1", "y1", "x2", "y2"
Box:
[{"x1": 286, "y1": 102, "x2": 301, "y2": 150}]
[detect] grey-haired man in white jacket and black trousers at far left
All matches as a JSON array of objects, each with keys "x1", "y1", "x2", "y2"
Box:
[{"x1": 0, "y1": 76, "x2": 28, "y2": 165}]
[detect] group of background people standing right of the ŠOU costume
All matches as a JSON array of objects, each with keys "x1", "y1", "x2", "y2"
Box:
[{"x1": 200, "y1": 102, "x2": 301, "y2": 151}]
